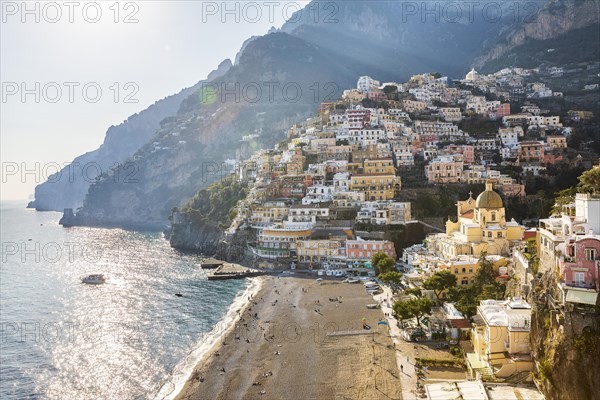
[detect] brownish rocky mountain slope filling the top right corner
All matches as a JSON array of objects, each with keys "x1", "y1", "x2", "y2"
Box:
[{"x1": 473, "y1": 0, "x2": 600, "y2": 73}]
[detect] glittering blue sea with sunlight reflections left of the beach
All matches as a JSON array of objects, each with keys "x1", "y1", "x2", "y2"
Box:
[{"x1": 0, "y1": 202, "x2": 258, "y2": 400}]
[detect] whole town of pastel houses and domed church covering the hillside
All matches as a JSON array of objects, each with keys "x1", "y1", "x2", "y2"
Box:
[{"x1": 204, "y1": 68, "x2": 600, "y2": 396}]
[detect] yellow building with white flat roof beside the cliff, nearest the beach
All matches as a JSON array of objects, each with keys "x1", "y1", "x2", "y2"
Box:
[{"x1": 467, "y1": 299, "x2": 533, "y2": 378}]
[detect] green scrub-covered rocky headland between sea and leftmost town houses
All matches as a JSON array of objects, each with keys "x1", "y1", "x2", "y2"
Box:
[{"x1": 179, "y1": 176, "x2": 248, "y2": 228}]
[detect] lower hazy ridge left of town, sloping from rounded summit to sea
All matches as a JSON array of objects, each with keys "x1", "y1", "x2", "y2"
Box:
[{"x1": 63, "y1": 32, "x2": 379, "y2": 229}]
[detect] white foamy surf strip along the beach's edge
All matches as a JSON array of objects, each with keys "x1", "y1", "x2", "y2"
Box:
[{"x1": 154, "y1": 276, "x2": 264, "y2": 400}]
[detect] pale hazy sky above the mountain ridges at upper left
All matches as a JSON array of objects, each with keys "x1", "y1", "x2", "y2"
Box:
[{"x1": 0, "y1": 1, "x2": 300, "y2": 200}]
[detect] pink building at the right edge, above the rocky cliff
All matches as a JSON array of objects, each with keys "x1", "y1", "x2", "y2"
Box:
[{"x1": 560, "y1": 235, "x2": 600, "y2": 290}]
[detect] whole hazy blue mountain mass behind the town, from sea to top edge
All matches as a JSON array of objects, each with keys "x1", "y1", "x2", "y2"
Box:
[{"x1": 51, "y1": 0, "x2": 596, "y2": 229}]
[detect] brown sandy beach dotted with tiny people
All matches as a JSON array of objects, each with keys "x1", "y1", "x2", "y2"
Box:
[{"x1": 177, "y1": 277, "x2": 402, "y2": 400}]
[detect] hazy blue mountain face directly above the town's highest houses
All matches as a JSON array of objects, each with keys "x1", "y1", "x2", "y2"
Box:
[{"x1": 281, "y1": 0, "x2": 546, "y2": 81}]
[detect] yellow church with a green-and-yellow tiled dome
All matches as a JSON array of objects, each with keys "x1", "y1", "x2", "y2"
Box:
[{"x1": 429, "y1": 180, "x2": 525, "y2": 258}]
